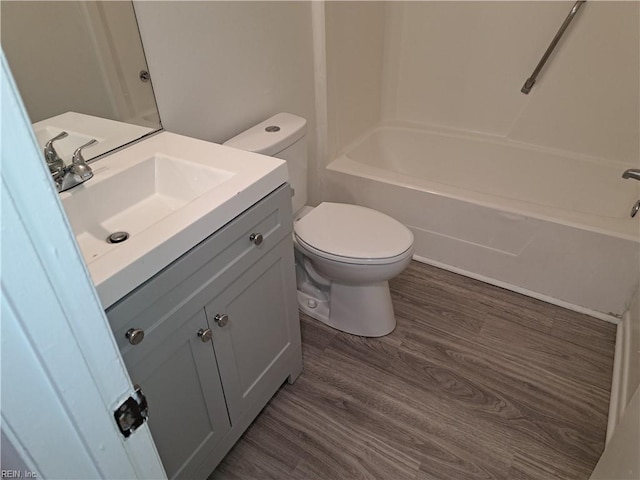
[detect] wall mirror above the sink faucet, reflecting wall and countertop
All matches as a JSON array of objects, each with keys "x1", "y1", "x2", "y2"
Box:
[{"x1": 0, "y1": 1, "x2": 161, "y2": 162}]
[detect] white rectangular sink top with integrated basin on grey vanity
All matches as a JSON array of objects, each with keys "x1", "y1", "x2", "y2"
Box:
[{"x1": 60, "y1": 132, "x2": 287, "y2": 308}]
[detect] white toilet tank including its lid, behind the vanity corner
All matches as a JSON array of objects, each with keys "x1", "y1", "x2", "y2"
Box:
[{"x1": 223, "y1": 113, "x2": 308, "y2": 213}]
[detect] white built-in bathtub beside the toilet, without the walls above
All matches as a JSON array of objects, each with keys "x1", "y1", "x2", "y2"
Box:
[{"x1": 323, "y1": 126, "x2": 640, "y2": 321}]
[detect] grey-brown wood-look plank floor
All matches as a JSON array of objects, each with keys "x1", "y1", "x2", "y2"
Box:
[{"x1": 210, "y1": 262, "x2": 616, "y2": 480}]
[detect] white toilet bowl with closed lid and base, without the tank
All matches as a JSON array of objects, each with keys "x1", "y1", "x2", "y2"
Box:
[{"x1": 294, "y1": 202, "x2": 413, "y2": 337}]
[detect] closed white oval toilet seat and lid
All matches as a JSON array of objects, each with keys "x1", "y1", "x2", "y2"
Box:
[{"x1": 294, "y1": 202, "x2": 413, "y2": 264}]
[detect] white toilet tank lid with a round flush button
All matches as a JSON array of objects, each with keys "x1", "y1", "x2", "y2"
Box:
[{"x1": 223, "y1": 112, "x2": 307, "y2": 156}]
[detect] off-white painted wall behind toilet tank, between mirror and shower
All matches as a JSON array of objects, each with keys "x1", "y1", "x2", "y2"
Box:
[{"x1": 135, "y1": 1, "x2": 315, "y2": 201}]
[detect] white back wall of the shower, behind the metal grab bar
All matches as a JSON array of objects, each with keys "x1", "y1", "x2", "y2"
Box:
[{"x1": 382, "y1": 1, "x2": 640, "y2": 165}]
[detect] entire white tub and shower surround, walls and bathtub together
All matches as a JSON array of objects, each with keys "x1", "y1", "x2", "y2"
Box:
[{"x1": 321, "y1": 2, "x2": 640, "y2": 321}]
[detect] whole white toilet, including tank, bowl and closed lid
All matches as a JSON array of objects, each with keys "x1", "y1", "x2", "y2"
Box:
[{"x1": 224, "y1": 113, "x2": 413, "y2": 337}]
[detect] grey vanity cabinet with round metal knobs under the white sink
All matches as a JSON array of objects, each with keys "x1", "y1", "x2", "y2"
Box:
[{"x1": 107, "y1": 185, "x2": 302, "y2": 478}]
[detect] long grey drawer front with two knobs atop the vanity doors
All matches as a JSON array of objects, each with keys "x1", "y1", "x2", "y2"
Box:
[{"x1": 106, "y1": 184, "x2": 292, "y2": 353}]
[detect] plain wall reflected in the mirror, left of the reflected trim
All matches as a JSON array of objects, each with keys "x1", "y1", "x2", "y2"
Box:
[{"x1": 1, "y1": 2, "x2": 117, "y2": 123}]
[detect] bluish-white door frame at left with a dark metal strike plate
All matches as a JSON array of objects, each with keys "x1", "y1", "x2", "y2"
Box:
[{"x1": 0, "y1": 52, "x2": 166, "y2": 479}]
